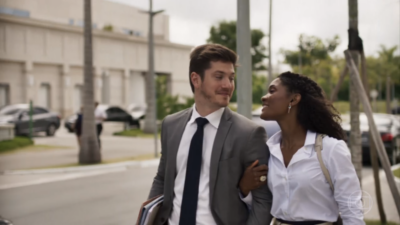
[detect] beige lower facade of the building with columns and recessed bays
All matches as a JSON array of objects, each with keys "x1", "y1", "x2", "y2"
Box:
[{"x1": 0, "y1": 13, "x2": 192, "y2": 116}]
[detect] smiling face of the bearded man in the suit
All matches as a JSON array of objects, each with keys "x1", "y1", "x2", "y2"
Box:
[{"x1": 198, "y1": 61, "x2": 235, "y2": 108}]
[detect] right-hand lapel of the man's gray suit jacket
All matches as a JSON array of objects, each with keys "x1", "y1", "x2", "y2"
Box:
[{"x1": 210, "y1": 107, "x2": 232, "y2": 202}]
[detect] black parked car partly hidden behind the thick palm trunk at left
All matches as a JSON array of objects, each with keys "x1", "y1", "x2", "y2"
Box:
[{"x1": 64, "y1": 105, "x2": 140, "y2": 132}]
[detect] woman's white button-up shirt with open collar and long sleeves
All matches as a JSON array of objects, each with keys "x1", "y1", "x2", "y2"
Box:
[{"x1": 243, "y1": 131, "x2": 365, "y2": 225}]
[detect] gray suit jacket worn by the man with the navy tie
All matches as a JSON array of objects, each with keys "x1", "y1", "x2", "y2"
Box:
[{"x1": 149, "y1": 108, "x2": 272, "y2": 225}]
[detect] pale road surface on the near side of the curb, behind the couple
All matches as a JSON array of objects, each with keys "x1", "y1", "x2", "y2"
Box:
[{"x1": 0, "y1": 163, "x2": 400, "y2": 225}]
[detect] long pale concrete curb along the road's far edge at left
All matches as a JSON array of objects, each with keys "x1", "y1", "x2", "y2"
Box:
[{"x1": 1, "y1": 159, "x2": 160, "y2": 175}]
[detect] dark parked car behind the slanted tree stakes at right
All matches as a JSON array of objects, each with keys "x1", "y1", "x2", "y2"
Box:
[{"x1": 342, "y1": 113, "x2": 400, "y2": 164}]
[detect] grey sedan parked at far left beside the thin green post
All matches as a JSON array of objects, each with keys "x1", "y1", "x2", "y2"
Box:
[{"x1": 0, "y1": 104, "x2": 60, "y2": 136}]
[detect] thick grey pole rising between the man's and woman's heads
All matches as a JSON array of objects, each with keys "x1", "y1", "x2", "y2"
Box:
[{"x1": 236, "y1": 0, "x2": 253, "y2": 119}]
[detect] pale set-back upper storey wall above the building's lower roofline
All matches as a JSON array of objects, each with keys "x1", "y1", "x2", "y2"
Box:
[{"x1": 0, "y1": 0, "x2": 169, "y2": 40}]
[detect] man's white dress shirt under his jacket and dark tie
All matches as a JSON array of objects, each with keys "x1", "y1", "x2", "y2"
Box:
[{"x1": 168, "y1": 105, "x2": 225, "y2": 225}]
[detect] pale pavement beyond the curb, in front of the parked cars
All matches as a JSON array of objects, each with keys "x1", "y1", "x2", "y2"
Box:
[{"x1": 0, "y1": 123, "x2": 160, "y2": 171}]
